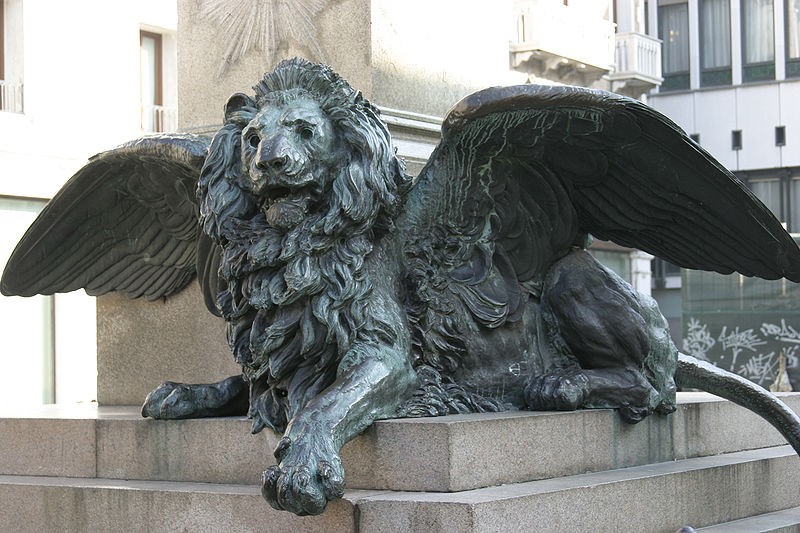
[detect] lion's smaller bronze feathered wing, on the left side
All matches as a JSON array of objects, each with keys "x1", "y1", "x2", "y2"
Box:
[{"x1": 0, "y1": 134, "x2": 222, "y2": 308}]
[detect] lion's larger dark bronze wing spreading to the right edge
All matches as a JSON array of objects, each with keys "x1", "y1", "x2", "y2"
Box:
[{"x1": 402, "y1": 85, "x2": 800, "y2": 316}]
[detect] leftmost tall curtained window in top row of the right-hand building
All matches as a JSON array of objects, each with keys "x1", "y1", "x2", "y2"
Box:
[{"x1": 658, "y1": 2, "x2": 689, "y2": 91}]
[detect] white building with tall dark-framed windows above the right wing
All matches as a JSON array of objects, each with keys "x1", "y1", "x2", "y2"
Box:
[{"x1": 649, "y1": 0, "x2": 800, "y2": 216}]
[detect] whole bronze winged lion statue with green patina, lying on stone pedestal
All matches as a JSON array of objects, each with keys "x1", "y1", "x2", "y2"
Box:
[{"x1": 2, "y1": 59, "x2": 800, "y2": 515}]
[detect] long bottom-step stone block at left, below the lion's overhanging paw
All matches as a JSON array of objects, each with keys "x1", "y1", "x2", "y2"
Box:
[{"x1": 0, "y1": 476, "x2": 373, "y2": 533}]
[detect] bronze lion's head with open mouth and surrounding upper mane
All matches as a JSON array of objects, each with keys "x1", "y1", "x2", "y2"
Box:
[{"x1": 198, "y1": 59, "x2": 407, "y2": 242}]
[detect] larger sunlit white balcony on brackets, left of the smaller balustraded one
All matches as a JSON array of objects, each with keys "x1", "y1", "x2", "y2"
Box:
[{"x1": 510, "y1": 0, "x2": 614, "y2": 85}]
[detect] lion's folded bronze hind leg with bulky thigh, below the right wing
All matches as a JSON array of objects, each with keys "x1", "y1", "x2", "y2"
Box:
[{"x1": 525, "y1": 251, "x2": 677, "y2": 422}]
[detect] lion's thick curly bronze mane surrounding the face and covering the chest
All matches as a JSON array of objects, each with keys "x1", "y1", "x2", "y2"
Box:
[{"x1": 198, "y1": 59, "x2": 408, "y2": 432}]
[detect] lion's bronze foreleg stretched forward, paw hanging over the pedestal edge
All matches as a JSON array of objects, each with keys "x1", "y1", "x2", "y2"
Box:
[{"x1": 261, "y1": 345, "x2": 417, "y2": 515}]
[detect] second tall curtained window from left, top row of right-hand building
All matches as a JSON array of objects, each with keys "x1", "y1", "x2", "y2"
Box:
[{"x1": 699, "y1": 0, "x2": 731, "y2": 86}]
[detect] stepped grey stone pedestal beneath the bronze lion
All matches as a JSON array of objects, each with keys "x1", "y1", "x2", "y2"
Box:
[{"x1": 0, "y1": 393, "x2": 800, "y2": 533}]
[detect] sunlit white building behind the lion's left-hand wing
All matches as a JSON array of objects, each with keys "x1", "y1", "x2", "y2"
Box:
[{"x1": 0, "y1": 0, "x2": 177, "y2": 403}]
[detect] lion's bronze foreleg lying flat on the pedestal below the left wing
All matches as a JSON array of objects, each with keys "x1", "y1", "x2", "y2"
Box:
[{"x1": 142, "y1": 375, "x2": 249, "y2": 420}]
